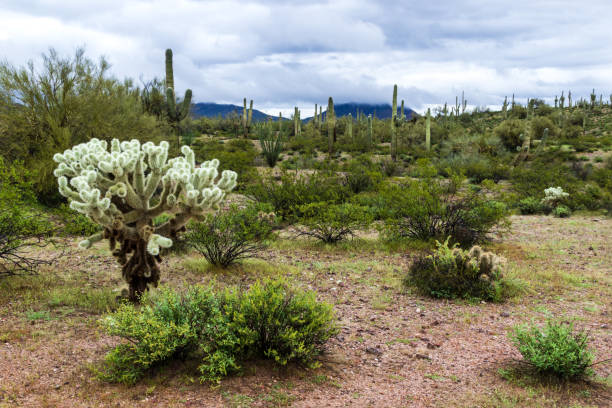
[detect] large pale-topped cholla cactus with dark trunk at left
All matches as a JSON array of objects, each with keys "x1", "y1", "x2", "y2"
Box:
[{"x1": 53, "y1": 139, "x2": 236, "y2": 301}]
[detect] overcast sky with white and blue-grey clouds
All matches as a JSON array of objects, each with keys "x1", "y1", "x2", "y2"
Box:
[{"x1": 0, "y1": 0, "x2": 612, "y2": 117}]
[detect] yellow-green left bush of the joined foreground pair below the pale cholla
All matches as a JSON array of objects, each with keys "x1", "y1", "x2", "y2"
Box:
[{"x1": 97, "y1": 286, "x2": 226, "y2": 384}]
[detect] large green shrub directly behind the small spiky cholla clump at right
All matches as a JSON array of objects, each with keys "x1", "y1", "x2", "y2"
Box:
[{"x1": 381, "y1": 168, "x2": 508, "y2": 246}]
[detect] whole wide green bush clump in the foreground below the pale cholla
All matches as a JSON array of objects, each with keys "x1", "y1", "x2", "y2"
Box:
[{"x1": 98, "y1": 279, "x2": 337, "y2": 384}]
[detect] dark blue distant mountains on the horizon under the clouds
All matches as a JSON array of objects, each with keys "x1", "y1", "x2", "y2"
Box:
[{"x1": 191, "y1": 102, "x2": 416, "y2": 122}]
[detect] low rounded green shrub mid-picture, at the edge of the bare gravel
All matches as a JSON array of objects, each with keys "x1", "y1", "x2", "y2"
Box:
[{"x1": 299, "y1": 202, "x2": 373, "y2": 244}]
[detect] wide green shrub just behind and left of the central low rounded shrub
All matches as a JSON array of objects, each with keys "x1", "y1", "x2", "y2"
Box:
[{"x1": 247, "y1": 172, "x2": 350, "y2": 222}]
